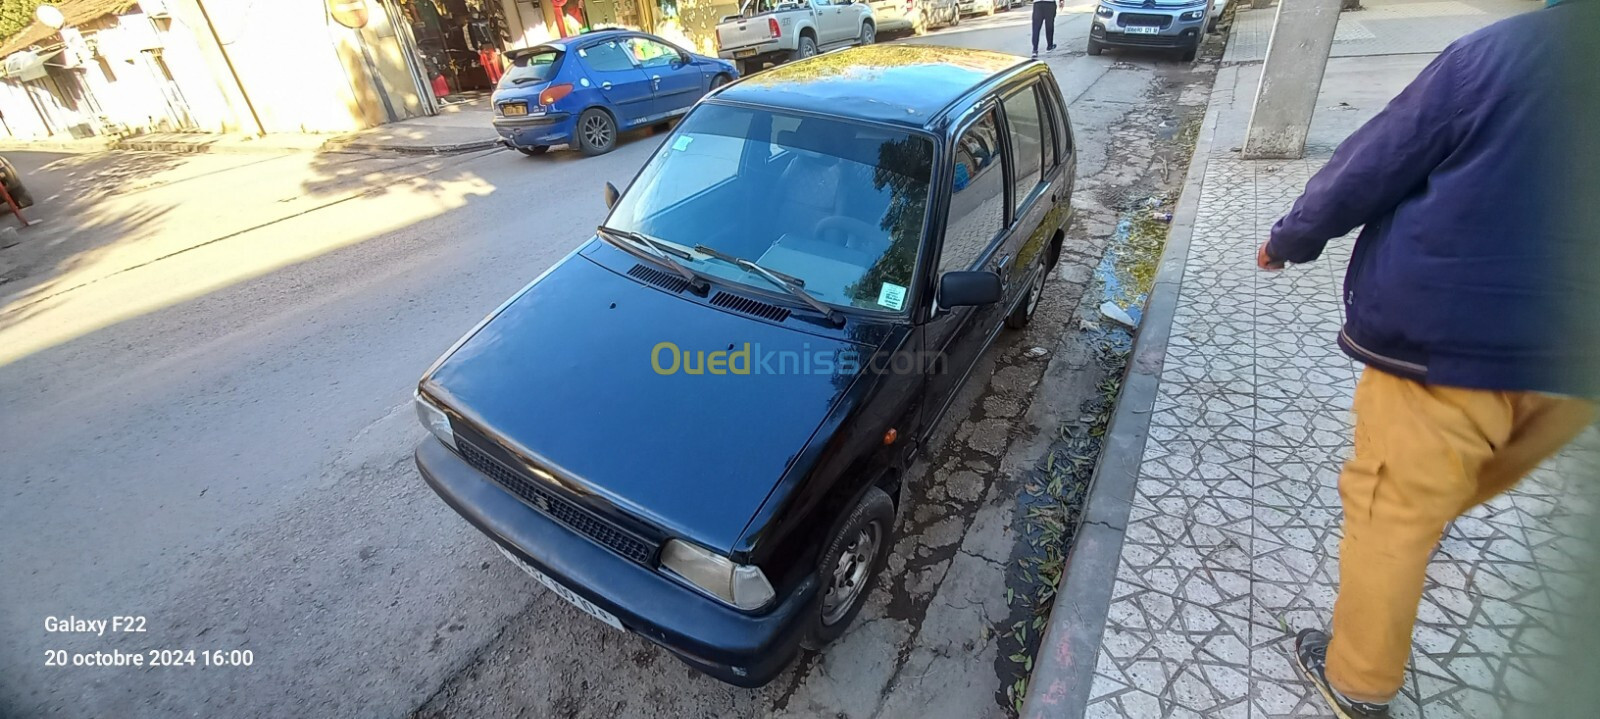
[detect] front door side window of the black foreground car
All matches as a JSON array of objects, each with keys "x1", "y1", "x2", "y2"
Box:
[{"x1": 939, "y1": 110, "x2": 1005, "y2": 272}]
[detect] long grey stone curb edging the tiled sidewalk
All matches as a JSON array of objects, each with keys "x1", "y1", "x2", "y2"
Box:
[{"x1": 1021, "y1": 63, "x2": 1219, "y2": 719}]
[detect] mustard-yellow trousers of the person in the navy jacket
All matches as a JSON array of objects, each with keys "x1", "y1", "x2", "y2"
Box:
[{"x1": 1328, "y1": 368, "x2": 1595, "y2": 703}]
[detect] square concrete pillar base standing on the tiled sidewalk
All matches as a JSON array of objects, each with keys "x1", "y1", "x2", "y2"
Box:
[{"x1": 1243, "y1": 0, "x2": 1341, "y2": 159}]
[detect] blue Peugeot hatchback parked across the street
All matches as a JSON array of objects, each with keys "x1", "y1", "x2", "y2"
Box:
[{"x1": 493, "y1": 30, "x2": 739, "y2": 155}]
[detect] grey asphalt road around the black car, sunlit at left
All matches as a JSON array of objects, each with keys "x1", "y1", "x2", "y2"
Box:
[{"x1": 0, "y1": 6, "x2": 1209, "y2": 717}]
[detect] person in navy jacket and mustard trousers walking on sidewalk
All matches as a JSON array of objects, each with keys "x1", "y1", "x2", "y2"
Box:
[{"x1": 1256, "y1": 3, "x2": 1600, "y2": 717}]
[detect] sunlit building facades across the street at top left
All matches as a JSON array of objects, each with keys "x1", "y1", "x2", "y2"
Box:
[{"x1": 0, "y1": 0, "x2": 738, "y2": 139}]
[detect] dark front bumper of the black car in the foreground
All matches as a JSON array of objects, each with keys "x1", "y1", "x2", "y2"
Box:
[{"x1": 416, "y1": 437, "x2": 819, "y2": 687}]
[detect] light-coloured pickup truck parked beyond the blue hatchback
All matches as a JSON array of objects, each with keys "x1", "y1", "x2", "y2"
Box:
[{"x1": 717, "y1": 0, "x2": 877, "y2": 75}]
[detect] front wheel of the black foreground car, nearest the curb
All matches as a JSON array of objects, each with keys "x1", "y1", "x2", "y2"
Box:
[{"x1": 800, "y1": 487, "x2": 894, "y2": 652}]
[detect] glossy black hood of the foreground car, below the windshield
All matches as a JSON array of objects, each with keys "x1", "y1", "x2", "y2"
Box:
[{"x1": 424, "y1": 255, "x2": 866, "y2": 552}]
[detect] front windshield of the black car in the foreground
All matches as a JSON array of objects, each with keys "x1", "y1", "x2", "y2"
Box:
[{"x1": 606, "y1": 104, "x2": 933, "y2": 312}]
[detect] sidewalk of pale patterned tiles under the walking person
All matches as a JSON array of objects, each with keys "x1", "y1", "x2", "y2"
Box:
[{"x1": 1075, "y1": 36, "x2": 1600, "y2": 719}]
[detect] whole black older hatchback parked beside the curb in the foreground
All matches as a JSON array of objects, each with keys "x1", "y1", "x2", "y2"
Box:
[{"x1": 416, "y1": 45, "x2": 1077, "y2": 687}]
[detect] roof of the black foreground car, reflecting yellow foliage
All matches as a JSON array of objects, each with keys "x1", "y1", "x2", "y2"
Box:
[{"x1": 717, "y1": 45, "x2": 1029, "y2": 128}]
